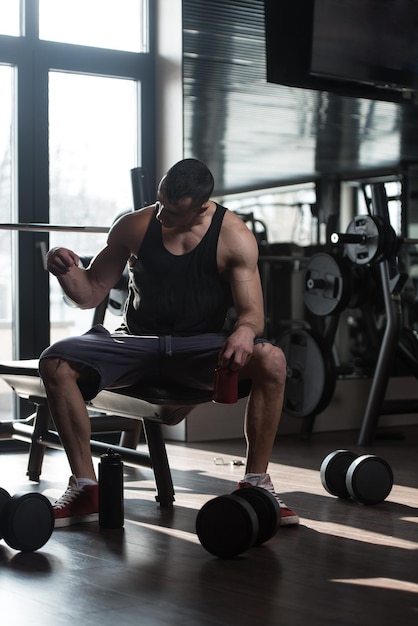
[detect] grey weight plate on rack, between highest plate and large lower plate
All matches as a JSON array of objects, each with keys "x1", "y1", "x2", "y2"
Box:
[{"x1": 303, "y1": 252, "x2": 350, "y2": 316}]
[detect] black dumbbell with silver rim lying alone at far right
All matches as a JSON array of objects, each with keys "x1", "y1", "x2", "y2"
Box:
[{"x1": 320, "y1": 450, "x2": 393, "y2": 504}]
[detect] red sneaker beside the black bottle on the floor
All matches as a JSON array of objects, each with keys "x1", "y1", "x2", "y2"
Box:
[{"x1": 53, "y1": 476, "x2": 99, "y2": 528}]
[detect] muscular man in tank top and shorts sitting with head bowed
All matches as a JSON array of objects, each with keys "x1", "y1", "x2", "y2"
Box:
[{"x1": 39, "y1": 159, "x2": 299, "y2": 527}]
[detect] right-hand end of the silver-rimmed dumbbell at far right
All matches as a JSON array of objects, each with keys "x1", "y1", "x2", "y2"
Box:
[{"x1": 346, "y1": 454, "x2": 393, "y2": 504}]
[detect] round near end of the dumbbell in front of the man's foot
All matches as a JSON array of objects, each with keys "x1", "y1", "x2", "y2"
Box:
[{"x1": 196, "y1": 495, "x2": 258, "y2": 559}]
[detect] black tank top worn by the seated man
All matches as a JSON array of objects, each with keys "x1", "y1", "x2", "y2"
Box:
[{"x1": 124, "y1": 204, "x2": 231, "y2": 335}]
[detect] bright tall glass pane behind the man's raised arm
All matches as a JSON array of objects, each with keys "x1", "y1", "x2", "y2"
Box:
[{"x1": 49, "y1": 72, "x2": 139, "y2": 340}]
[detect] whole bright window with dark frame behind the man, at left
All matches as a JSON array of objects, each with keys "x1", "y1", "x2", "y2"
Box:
[{"x1": 0, "y1": 0, "x2": 156, "y2": 410}]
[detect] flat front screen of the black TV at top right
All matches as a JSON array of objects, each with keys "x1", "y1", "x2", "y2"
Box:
[{"x1": 311, "y1": 0, "x2": 418, "y2": 90}]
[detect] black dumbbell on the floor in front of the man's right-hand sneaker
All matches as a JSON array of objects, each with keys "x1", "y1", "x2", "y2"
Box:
[{"x1": 196, "y1": 487, "x2": 281, "y2": 559}]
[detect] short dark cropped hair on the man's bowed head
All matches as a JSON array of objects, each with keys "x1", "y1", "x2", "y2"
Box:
[{"x1": 161, "y1": 159, "x2": 214, "y2": 206}]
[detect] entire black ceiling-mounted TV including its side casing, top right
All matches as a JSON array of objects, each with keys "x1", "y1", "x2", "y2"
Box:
[{"x1": 264, "y1": 0, "x2": 418, "y2": 102}]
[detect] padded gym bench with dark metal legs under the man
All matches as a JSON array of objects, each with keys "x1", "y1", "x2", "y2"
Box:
[{"x1": 0, "y1": 359, "x2": 251, "y2": 507}]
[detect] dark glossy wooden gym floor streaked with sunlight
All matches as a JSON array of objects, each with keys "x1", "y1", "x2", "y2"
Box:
[{"x1": 0, "y1": 427, "x2": 418, "y2": 626}]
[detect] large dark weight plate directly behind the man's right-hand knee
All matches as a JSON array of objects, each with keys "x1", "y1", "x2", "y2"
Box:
[{"x1": 278, "y1": 329, "x2": 337, "y2": 418}]
